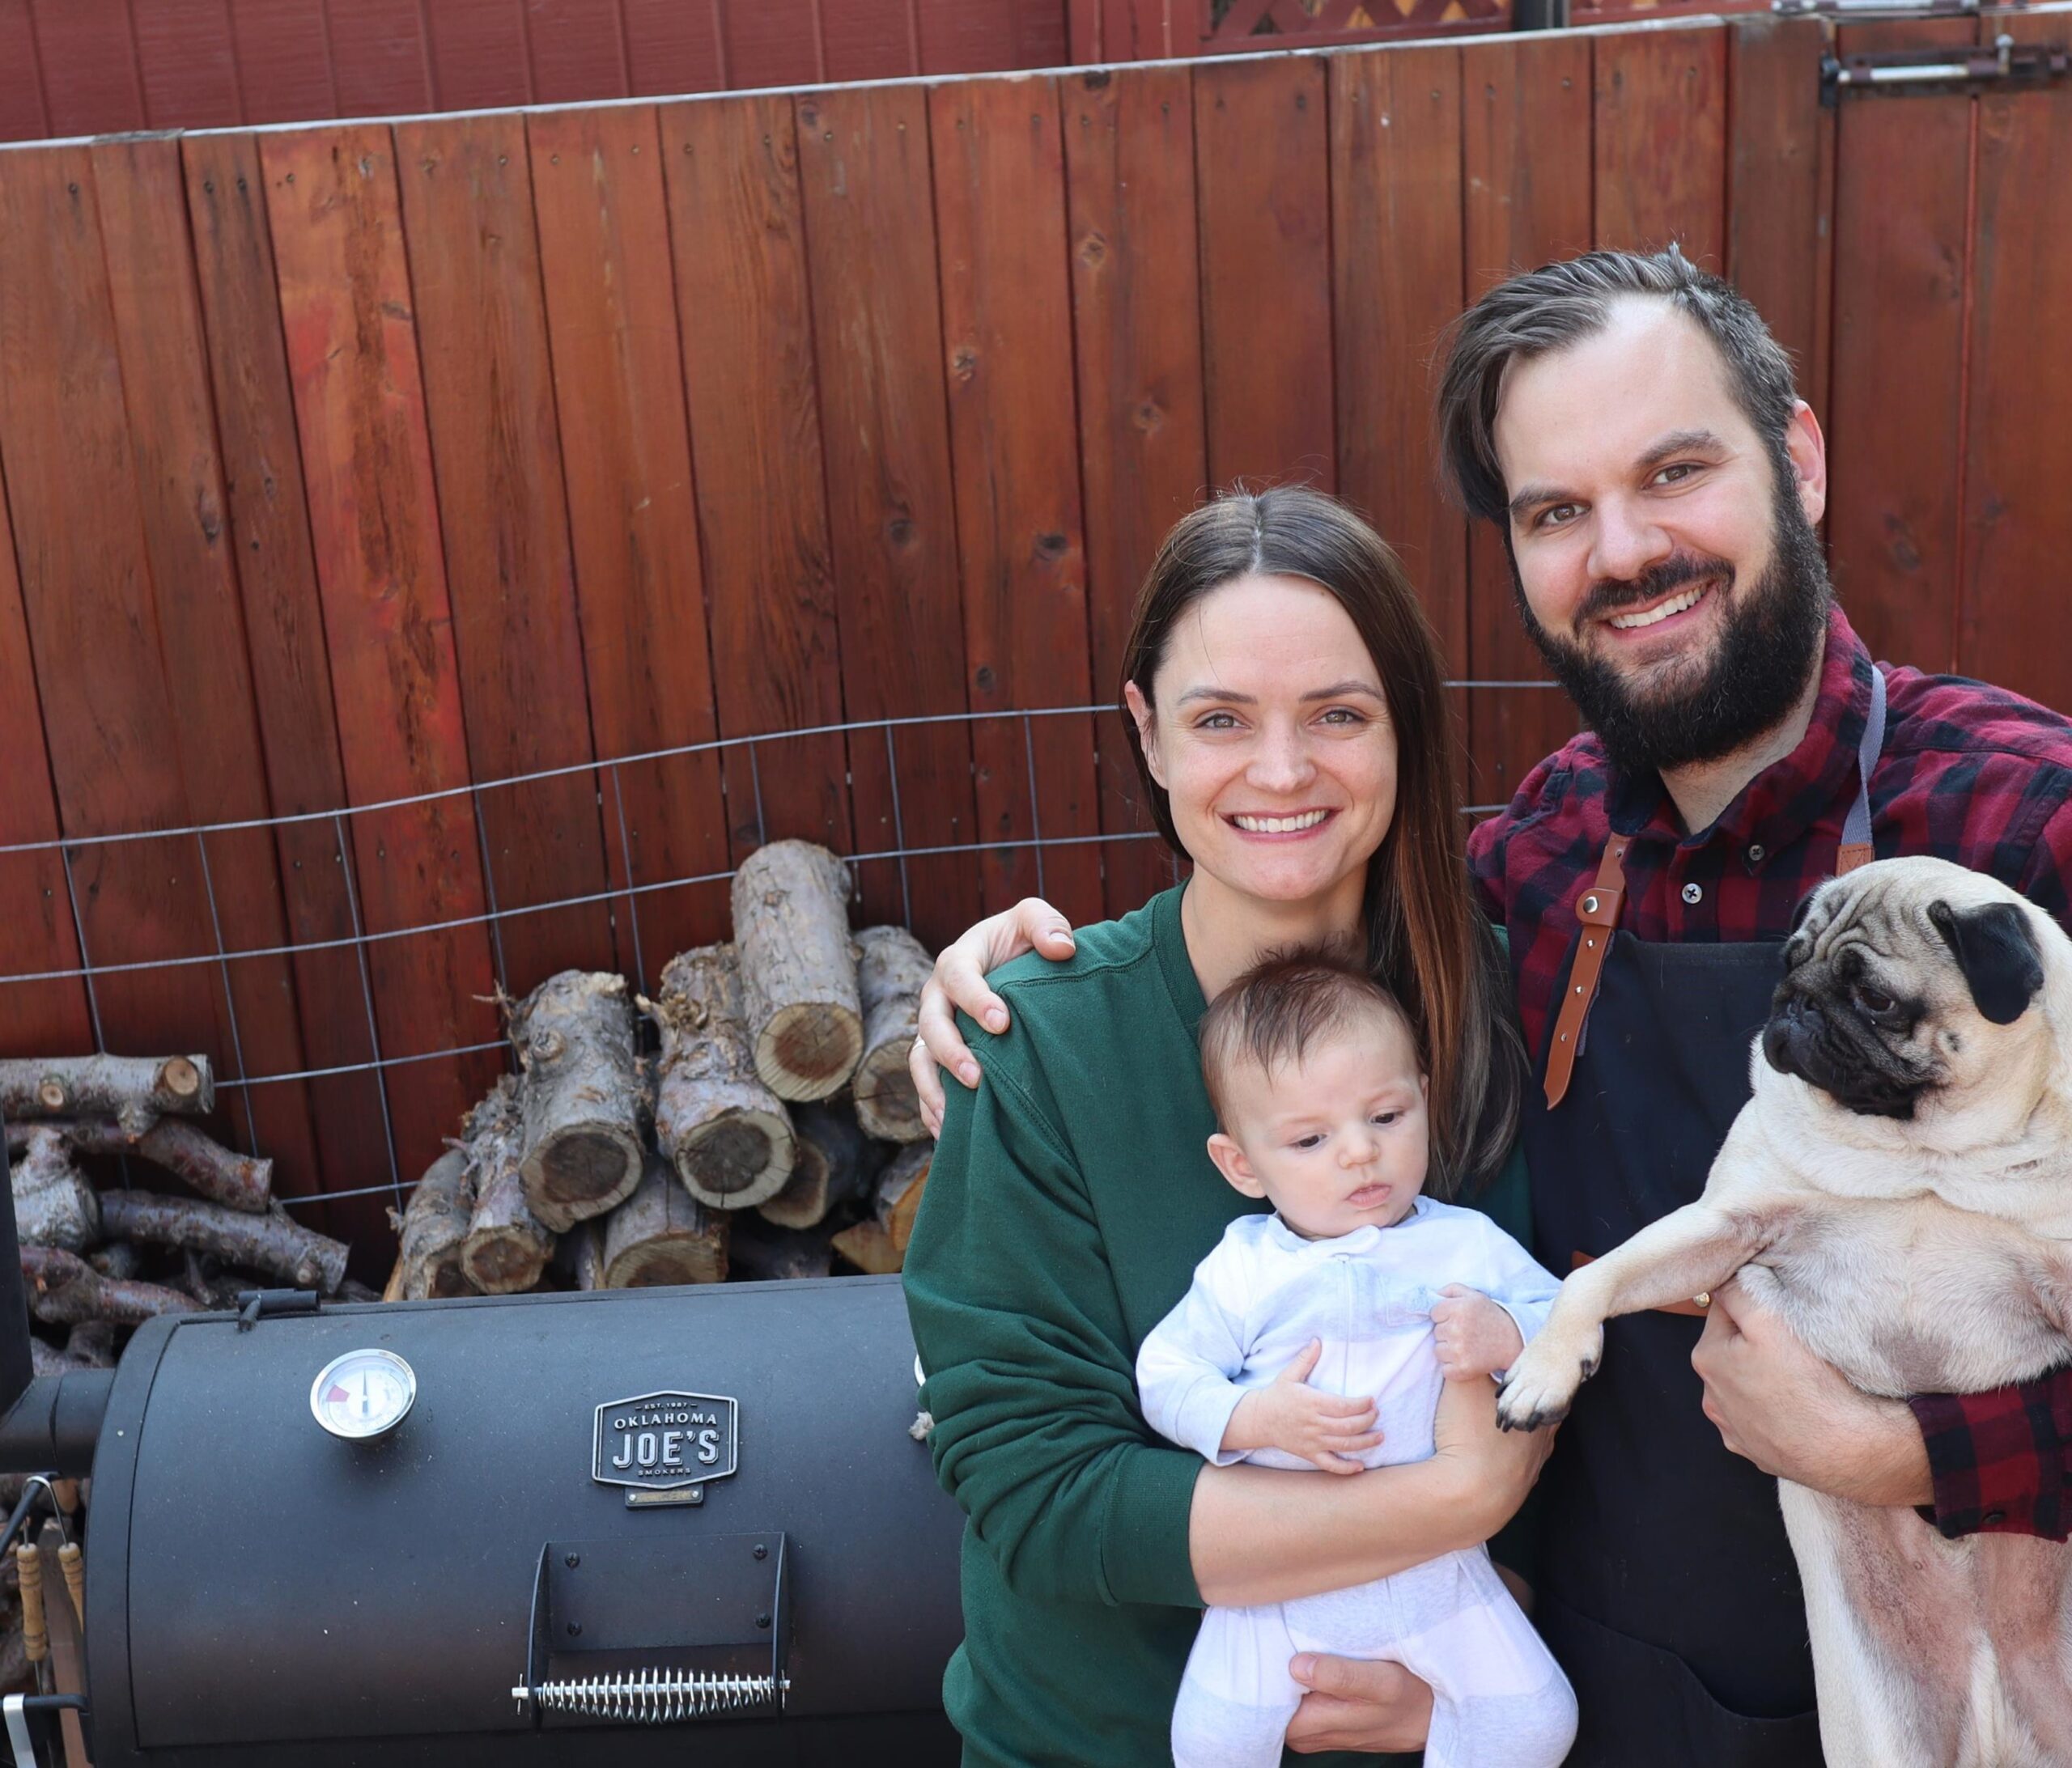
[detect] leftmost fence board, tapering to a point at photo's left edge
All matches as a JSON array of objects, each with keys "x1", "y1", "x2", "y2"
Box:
[{"x1": 0, "y1": 464, "x2": 93, "y2": 1056}]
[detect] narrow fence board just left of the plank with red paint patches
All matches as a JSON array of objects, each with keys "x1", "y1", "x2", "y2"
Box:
[{"x1": 180, "y1": 134, "x2": 388, "y2": 1246}]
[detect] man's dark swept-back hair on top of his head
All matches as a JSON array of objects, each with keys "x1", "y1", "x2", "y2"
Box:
[{"x1": 1438, "y1": 246, "x2": 1798, "y2": 522}]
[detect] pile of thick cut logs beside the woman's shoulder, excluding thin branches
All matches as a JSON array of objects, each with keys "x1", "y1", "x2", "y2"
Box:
[{"x1": 385, "y1": 841, "x2": 935, "y2": 1300}]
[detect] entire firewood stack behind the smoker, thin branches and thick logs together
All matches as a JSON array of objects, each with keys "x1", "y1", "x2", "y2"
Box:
[{"x1": 0, "y1": 841, "x2": 935, "y2": 1372}]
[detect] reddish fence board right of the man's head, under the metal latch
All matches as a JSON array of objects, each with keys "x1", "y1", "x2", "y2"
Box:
[{"x1": 1828, "y1": 19, "x2": 1976, "y2": 668}]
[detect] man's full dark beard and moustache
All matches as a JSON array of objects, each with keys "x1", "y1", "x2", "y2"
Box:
[{"x1": 1510, "y1": 474, "x2": 1834, "y2": 774}]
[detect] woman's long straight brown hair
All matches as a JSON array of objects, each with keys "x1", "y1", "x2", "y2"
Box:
[{"x1": 1123, "y1": 485, "x2": 1525, "y2": 1197}]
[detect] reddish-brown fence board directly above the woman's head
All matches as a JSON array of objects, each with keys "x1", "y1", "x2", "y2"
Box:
[{"x1": 1194, "y1": 56, "x2": 1336, "y2": 490}]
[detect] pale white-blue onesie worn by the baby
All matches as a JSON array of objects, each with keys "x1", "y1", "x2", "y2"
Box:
[{"x1": 1137, "y1": 1197, "x2": 1575, "y2": 1768}]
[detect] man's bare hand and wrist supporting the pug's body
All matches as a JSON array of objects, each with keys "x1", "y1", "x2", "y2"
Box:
[{"x1": 1691, "y1": 1283, "x2": 1933, "y2": 1505}]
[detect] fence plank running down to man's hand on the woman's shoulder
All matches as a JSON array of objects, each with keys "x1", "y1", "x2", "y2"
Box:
[{"x1": 928, "y1": 81, "x2": 1102, "y2": 922}]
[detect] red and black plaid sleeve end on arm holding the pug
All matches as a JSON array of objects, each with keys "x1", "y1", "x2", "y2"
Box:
[{"x1": 1909, "y1": 1368, "x2": 2072, "y2": 1541}]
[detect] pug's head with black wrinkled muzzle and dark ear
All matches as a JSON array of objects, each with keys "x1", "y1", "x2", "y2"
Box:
[{"x1": 1764, "y1": 859, "x2": 2043, "y2": 1118}]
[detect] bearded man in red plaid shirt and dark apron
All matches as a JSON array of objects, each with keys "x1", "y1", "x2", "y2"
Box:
[{"x1": 918, "y1": 248, "x2": 2072, "y2": 1768}]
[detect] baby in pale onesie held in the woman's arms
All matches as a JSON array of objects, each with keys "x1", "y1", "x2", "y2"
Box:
[{"x1": 1137, "y1": 952, "x2": 1575, "y2": 1768}]
